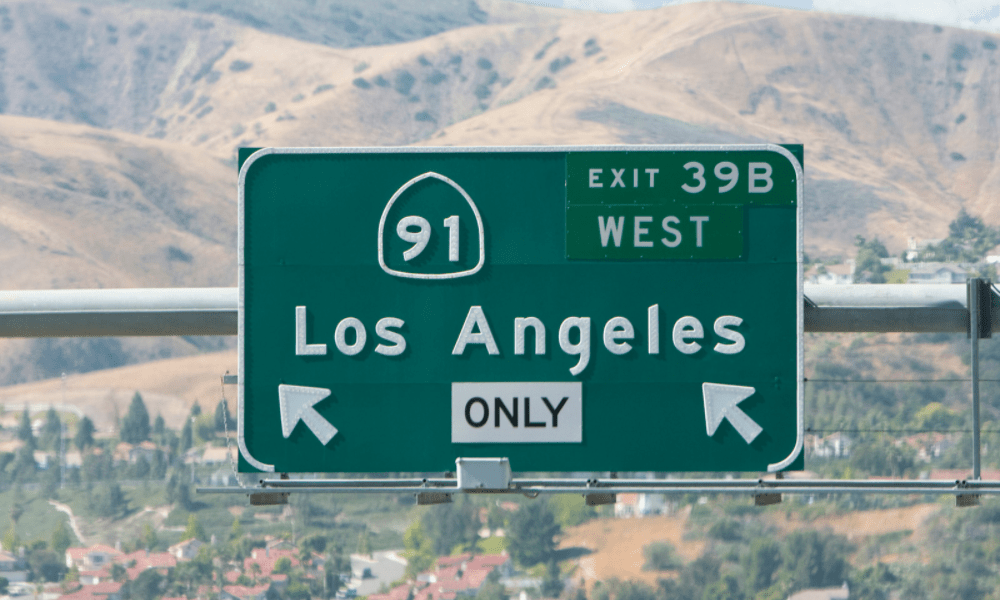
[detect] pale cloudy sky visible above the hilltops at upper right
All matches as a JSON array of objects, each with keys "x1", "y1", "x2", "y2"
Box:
[{"x1": 522, "y1": 0, "x2": 1000, "y2": 33}]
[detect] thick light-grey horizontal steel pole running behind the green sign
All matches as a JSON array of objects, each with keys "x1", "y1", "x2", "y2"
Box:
[{"x1": 0, "y1": 284, "x2": 988, "y2": 337}]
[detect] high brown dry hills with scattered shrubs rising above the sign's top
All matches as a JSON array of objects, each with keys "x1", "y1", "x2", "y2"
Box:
[{"x1": 0, "y1": 2, "x2": 1000, "y2": 255}]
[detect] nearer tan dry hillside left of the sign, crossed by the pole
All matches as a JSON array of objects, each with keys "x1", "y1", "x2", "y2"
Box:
[{"x1": 0, "y1": 116, "x2": 236, "y2": 383}]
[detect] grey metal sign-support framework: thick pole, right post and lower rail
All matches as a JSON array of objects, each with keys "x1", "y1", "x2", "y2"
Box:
[{"x1": 0, "y1": 280, "x2": 1000, "y2": 506}]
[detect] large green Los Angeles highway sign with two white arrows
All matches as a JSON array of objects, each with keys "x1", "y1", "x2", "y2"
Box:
[{"x1": 239, "y1": 145, "x2": 803, "y2": 472}]
